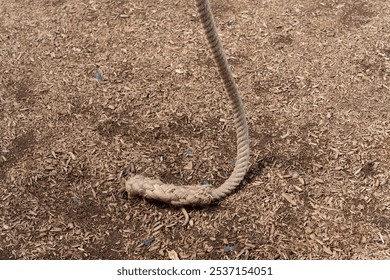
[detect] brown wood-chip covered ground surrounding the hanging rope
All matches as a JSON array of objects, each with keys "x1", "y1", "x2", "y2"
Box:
[{"x1": 0, "y1": 0, "x2": 390, "y2": 259}]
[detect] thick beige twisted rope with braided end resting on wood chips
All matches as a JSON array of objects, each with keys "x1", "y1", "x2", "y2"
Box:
[{"x1": 122, "y1": 0, "x2": 249, "y2": 206}]
